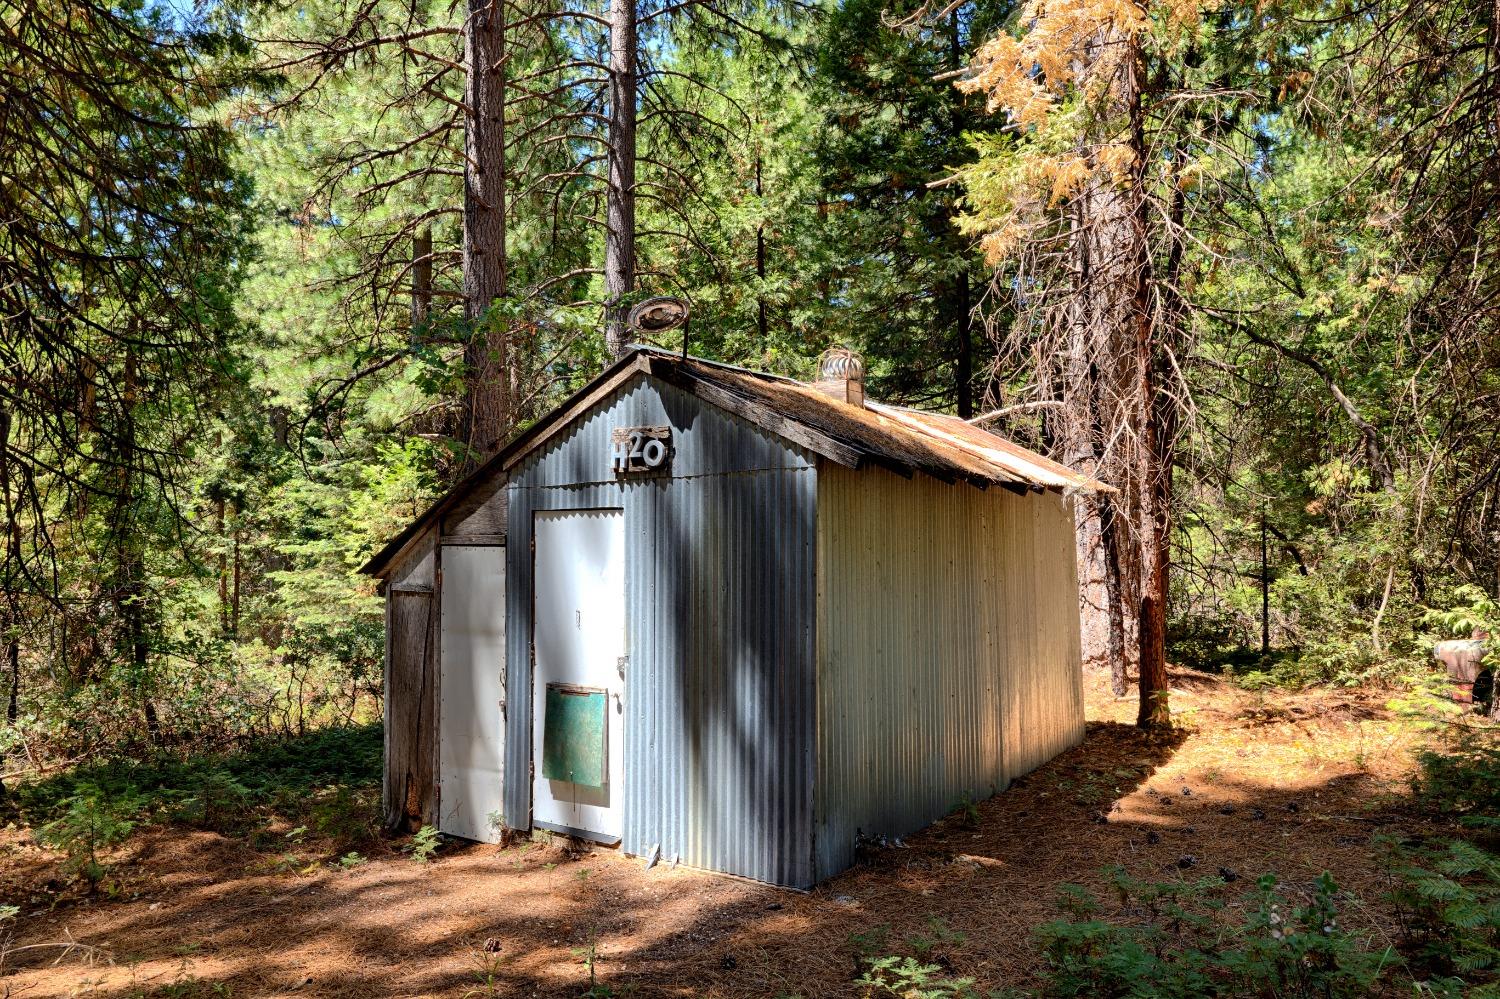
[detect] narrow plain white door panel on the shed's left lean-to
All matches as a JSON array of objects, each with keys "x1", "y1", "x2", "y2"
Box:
[{"x1": 438, "y1": 545, "x2": 506, "y2": 843}]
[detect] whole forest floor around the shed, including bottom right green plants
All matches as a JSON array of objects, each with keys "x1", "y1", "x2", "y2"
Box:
[{"x1": 0, "y1": 672, "x2": 1500, "y2": 999}]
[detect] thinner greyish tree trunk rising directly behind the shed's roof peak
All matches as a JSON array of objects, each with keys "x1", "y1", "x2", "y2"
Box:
[{"x1": 605, "y1": 0, "x2": 636, "y2": 357}]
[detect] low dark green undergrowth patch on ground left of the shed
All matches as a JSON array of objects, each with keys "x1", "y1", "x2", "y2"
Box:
[{"x1": 14, "y1": 725, "x2": 381, "y2": 885}]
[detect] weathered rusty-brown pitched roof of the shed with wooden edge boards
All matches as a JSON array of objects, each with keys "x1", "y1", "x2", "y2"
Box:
[{"x1": 360, "y1": 345, "x2": 1113, "y2": 576}]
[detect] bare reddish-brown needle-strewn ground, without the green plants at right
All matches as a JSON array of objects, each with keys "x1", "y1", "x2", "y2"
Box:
[{"x1": 0, "y1": 672, "x2": 1452, "y2": 999}]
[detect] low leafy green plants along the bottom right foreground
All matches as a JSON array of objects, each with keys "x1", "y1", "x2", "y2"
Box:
[{"x1": 849, "y1": 840, "x2": 1500, "y2": 999}]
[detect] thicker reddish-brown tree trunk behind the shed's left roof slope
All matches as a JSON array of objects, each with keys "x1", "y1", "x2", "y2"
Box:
[{"x1": 459, "y1": 0, "x2": 513, "y2": 467}]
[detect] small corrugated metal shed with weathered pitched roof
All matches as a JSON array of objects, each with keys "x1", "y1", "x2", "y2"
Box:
[{"x1": 366, "y1": 348, "x2": 1107, "y2": 887}]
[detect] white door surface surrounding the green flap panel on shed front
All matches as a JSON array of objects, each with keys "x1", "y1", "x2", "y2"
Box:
[{"x1": 531, "y1": 510, "x2": 626, "y2": 843}]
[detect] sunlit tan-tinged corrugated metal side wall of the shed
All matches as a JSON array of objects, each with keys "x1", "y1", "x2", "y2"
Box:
[{"x1": 816, "y1": 464, "x2": 1083, "y2": 879}]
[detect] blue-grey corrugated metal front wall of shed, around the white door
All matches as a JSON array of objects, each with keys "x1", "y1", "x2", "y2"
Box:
[{"x1": 506, "y1": 378, "x2": 816, "y2": 885}]
